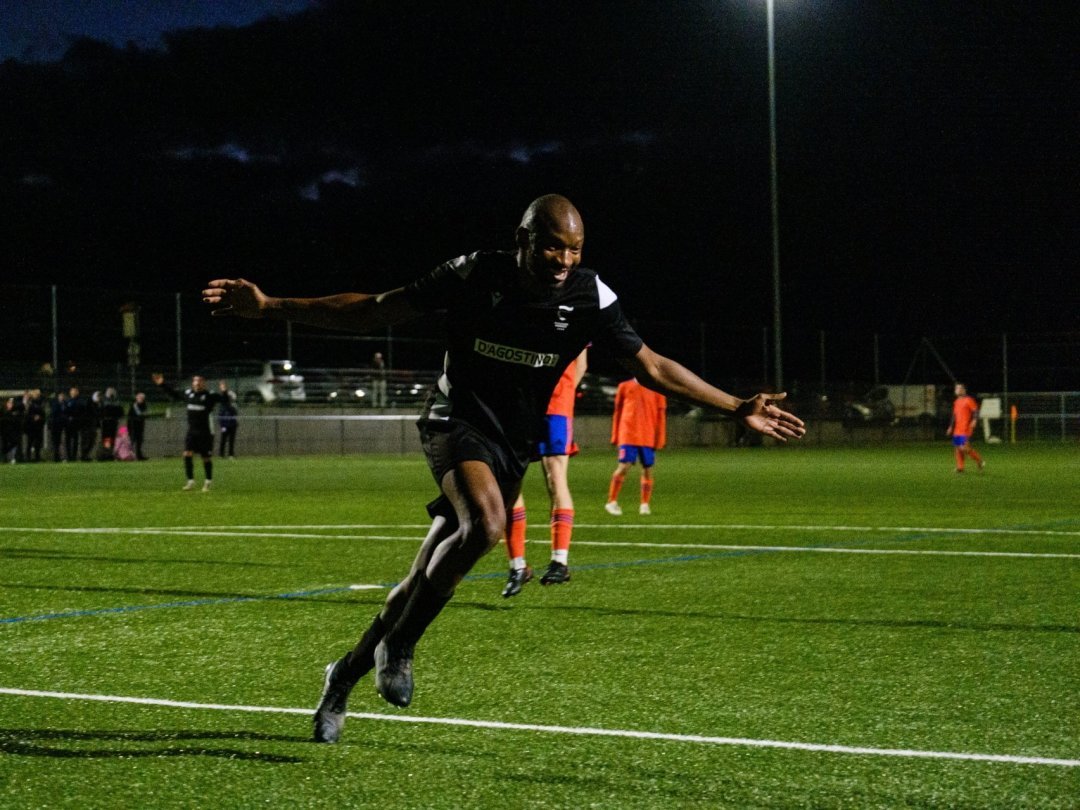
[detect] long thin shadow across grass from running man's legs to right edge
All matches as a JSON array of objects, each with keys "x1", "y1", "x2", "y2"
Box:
[{"x1": 494, "y1": 603, "x2": 1080, "y2": 633}]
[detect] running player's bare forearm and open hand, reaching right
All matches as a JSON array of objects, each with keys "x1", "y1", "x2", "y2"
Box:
[{"x1": 624, "y1": 346, "x2": 806, "y2": 442}]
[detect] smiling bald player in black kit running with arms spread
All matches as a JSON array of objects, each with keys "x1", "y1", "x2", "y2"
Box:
[{"x1": 203, "y1": 194, "x2": 805, "y2": 742}]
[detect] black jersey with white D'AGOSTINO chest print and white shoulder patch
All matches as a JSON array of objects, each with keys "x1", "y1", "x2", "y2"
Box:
[{"x1": 405, "y1": 252, "x2": 643, "y2": 462}]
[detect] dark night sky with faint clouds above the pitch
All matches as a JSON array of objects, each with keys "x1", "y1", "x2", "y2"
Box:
[{"x1": 0, "y1": 0, "x2": 1080, "y2": 390}]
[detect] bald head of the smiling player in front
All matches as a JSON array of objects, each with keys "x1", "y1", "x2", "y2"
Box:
[{"x1": 516, "y1": 194, "x2": 585, "y2": 289}]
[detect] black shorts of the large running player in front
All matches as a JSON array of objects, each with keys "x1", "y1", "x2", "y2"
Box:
[{"x1": 416, "y1": 419, "x2": 528, "y2": 517}]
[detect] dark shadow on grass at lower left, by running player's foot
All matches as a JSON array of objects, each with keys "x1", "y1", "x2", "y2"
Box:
[{"x1": 0, "y1": 728, "x2": 310, "y2": 764}]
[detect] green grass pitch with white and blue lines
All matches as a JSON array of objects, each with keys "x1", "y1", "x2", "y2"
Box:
[{"x1": 0, "y1": 444, "x2": 1080, "y2": 808}]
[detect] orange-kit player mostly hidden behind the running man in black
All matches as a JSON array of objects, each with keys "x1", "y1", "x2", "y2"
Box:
[{"x1": 502, "y1": 349, "x2": 589, "y2": 598}]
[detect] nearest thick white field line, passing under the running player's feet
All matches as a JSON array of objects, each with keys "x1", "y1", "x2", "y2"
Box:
[{"x1": 0, "y1": 687, "x2": 1080, "y2": 768}]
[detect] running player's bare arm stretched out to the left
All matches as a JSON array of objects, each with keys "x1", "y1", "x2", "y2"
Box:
[{"x1": 203, "y1": 279, "x2": 420, "y2": 332}]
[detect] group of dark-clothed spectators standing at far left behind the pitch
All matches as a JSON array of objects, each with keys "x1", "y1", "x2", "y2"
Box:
[{"x1": 0, "y1": 386, "x2": 149, "y2": 463}]
